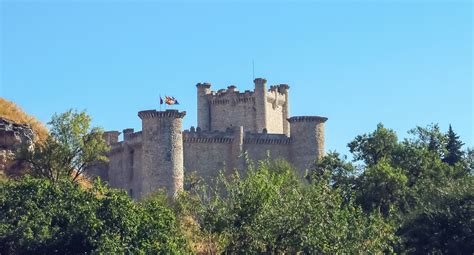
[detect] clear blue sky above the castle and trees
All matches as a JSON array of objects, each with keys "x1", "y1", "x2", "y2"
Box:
[{"x1": 0, "y1": 0, "x2": 474, "y2": 153}]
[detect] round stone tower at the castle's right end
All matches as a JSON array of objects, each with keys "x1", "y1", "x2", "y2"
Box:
[{"x1": 288, "y1": 116, "x2": 327, "y2": 177}]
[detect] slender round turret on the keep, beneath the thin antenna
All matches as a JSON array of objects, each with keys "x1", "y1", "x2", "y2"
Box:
[{"x1": 253, "y1": 78, "x2": 268, "y2": 132}]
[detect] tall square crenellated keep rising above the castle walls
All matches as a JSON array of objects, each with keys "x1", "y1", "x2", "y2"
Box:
[{"x1": 196, "y1": 78, "x2": 289, "y2": 135}]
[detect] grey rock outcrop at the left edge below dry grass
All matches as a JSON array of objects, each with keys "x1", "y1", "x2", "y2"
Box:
[{"x1": 0, "y1": 117, "x2": 35, "y2": 175}]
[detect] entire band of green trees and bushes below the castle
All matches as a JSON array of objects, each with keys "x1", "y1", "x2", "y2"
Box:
[{"x1": 0, "y1": 107, "x2": 474, "y2": 254}]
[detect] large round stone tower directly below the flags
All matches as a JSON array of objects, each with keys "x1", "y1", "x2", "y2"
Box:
[{"x1": 138, "y1": 110, "x2": 186, "y2": 197}]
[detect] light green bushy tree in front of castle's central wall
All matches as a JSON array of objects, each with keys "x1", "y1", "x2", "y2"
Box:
[{"x1": 187, "y1": 160, "x2": 396, "y2": 254}]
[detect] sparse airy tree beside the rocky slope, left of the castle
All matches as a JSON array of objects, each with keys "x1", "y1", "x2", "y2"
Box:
[{"x1": 19, "y1": 110, "x2": 109, "y2": 182}]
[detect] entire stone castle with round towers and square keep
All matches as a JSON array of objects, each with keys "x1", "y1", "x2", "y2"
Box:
[{"x1": 88, "y1": 78, "x2": 327, "y2": 199}]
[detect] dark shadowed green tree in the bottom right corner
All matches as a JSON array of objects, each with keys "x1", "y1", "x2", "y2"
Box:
[{"x1": 398, "y1": 176, "x2": 474, "y2": 254}]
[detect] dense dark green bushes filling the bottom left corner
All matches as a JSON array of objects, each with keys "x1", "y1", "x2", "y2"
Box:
[{"x1": 0, "y1": 177, "x2": 186, "y2": 254}]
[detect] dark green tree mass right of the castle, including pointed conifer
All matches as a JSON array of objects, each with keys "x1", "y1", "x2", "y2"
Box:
[{"x1": 312, "y1": 124, "x2": 474, "y2": 254}]
